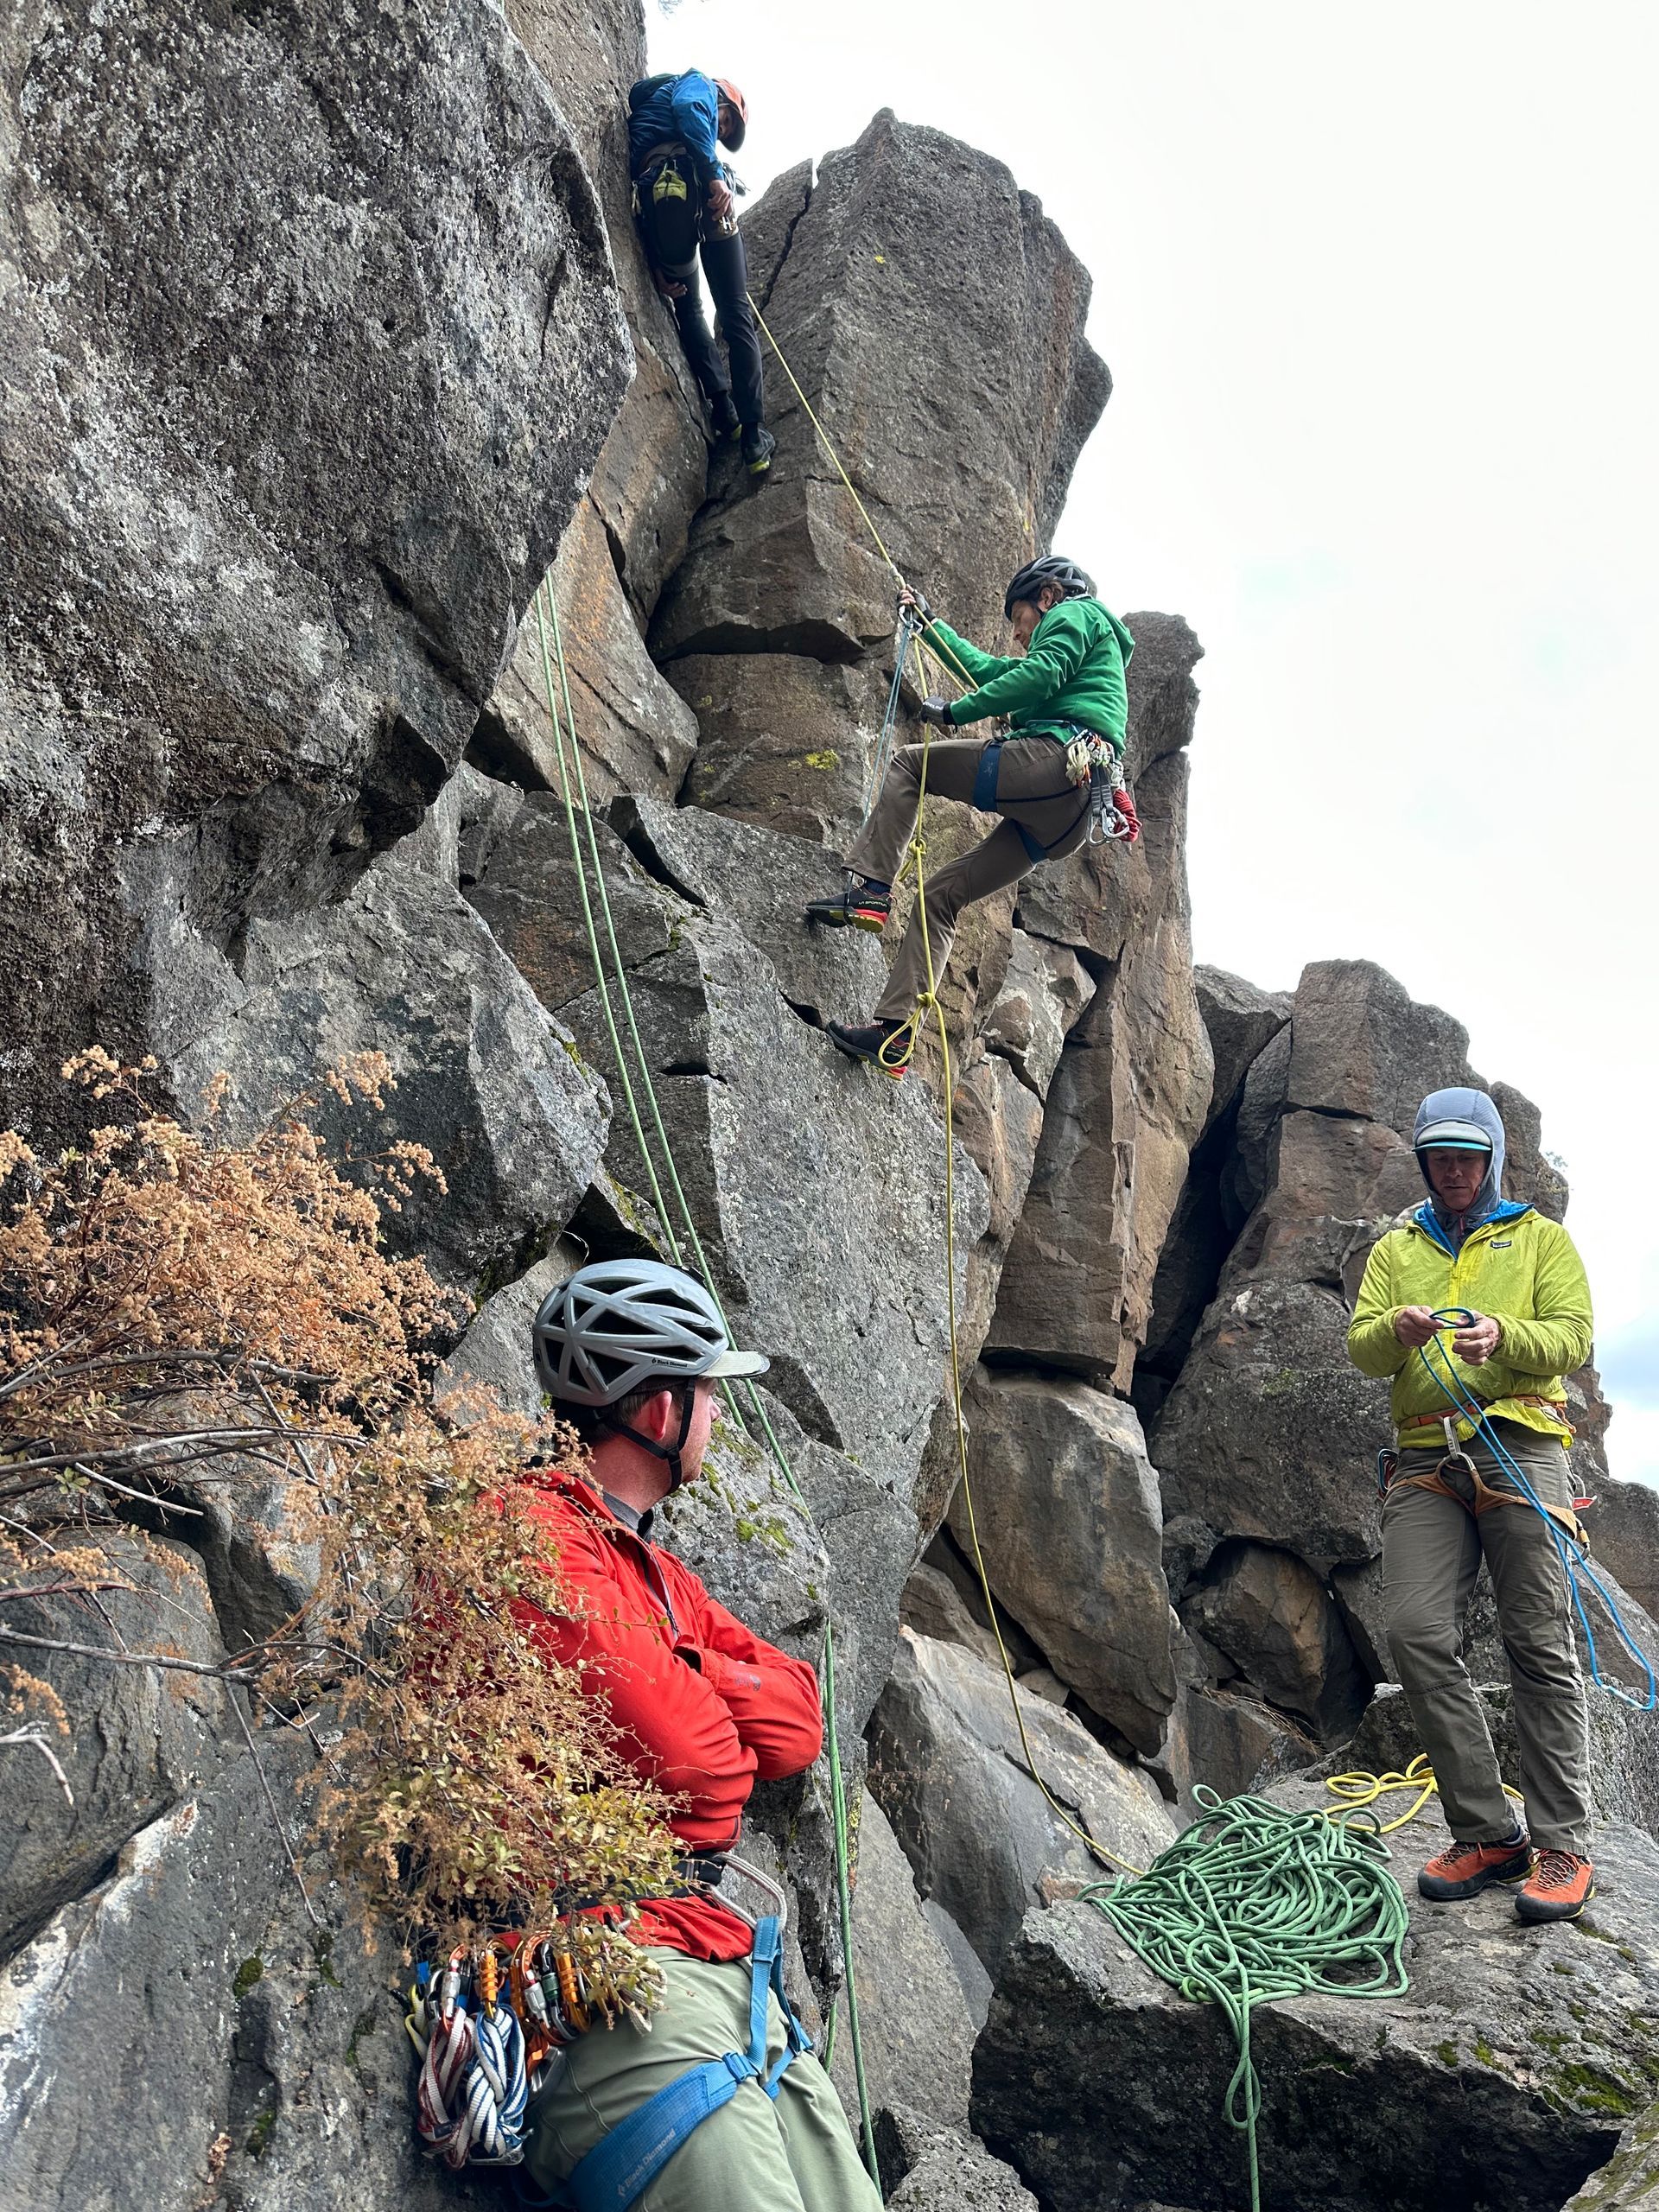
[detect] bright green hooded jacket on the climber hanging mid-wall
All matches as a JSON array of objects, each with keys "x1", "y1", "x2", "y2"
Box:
[{"x1": 923, "y1": 600, "x2": 1135, "y2": 752}]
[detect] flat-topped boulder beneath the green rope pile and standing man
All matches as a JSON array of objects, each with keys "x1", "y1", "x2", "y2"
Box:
[{"x1": 973, "y1": 1785, "x2": 1659, "y2": 2212}]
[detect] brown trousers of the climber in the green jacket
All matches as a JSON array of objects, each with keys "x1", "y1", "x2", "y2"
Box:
[{"x1": 847, "y1": 736, "x2": 1089, "y2": 1022}]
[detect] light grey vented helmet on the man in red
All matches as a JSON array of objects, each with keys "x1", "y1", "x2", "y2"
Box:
[{"x1": 531, "y1": 1259, "x2": 770, "y2": 1407}]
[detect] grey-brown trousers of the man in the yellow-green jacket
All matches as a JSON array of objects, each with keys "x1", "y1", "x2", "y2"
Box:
[{"x1": 1382, "y1": 1421, "x2": 1591, "y2": 1856}]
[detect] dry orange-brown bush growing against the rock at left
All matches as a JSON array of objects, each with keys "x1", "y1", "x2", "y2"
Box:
[{"x1": 0, "y1": 1051, "x2": 672, "y2": 2004}]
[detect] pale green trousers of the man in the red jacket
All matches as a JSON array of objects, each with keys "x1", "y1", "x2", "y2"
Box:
[{"x1": 524, "y1": 1947, "x2": 880, "y2": 2212}]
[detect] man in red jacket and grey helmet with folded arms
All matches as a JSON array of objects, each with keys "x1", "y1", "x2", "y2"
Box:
[{"x1": 515, "y1": 1261, "x2": 880, "y2": 2212}]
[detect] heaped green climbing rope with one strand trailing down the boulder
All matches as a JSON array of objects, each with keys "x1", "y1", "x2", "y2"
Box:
[{"x1": 1079, "y1": 1785, "x2": 1407, "y2": 2212}]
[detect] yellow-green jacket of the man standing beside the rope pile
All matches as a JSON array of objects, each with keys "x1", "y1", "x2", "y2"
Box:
[{"x1": 1347, "y1": 1205, "x2": 1595, "y2": 1451}]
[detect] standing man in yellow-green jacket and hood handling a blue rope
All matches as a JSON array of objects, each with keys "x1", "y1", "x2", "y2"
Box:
[{"x1": 1347, "y1": 1089, "x2": 1595, "y2": 1920}]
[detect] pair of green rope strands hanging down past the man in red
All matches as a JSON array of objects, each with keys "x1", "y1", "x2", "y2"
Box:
[{"x1": 533, "y1": 577, "x2": 880, "y2": 2188}]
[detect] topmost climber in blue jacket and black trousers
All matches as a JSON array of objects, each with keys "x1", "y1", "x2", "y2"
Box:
[{"x1": 628, "y1": 68, "x2": 777, "y2": 475}]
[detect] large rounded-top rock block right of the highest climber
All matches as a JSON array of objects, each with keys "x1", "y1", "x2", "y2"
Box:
[{"x1": 651, "y1": 111, "x2": 1110, "y2": 664}]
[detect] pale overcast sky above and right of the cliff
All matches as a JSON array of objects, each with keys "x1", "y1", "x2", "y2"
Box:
[{"x1": 651, "y1": 0, "x2": 1659, "y2": 1482}]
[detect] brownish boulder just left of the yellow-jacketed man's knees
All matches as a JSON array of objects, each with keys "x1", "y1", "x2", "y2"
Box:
[{"x1": 1181, "y1": 1544, "x2": 1371, "y2": 1743}]
